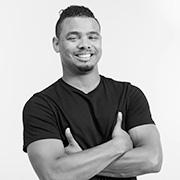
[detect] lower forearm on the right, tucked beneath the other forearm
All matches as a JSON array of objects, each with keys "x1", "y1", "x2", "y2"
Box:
[{"x1": 99, "y1": 146, "x2": 161, "y2": 178}]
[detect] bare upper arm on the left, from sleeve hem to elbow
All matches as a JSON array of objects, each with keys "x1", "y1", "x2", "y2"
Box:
[{"x1": 27, "y1": 139, "x2": 65, "y2": 180}]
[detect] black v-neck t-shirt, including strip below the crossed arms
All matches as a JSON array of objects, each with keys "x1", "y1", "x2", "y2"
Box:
[{"x1": 23, "y1": 75, "x2": 154, "y2": 180}]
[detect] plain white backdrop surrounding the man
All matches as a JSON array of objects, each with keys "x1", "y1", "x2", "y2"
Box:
[{"x1": 0, "y1": 0, "x2": 180, "y2": 180}]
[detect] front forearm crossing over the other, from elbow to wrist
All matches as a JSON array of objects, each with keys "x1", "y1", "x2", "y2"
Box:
[{"x1": 53, "y1": 140, "x2": 122, "y2": 180}]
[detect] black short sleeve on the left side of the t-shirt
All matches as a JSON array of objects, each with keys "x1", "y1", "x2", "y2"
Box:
[{"x1": 23, "y1": 95, "x2": 61, "y2": 152}]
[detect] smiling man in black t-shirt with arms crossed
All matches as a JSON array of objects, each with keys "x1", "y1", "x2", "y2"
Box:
[{"x1": 23, "y1": 6, "x2": 162, "y2": 180}]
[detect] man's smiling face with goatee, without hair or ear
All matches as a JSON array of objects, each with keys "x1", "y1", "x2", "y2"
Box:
[{"x1": 55, "y1": 17, "x2": 101, "y2": 73}]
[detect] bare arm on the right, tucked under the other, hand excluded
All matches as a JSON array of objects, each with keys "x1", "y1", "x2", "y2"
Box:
[{"x1": 99, "y1": 124, "x2": 162, "y2": 177}]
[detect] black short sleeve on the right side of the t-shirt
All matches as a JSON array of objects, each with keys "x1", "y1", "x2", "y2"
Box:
[{"x1": 125, "y1": 85, "x2": 154, "y2": 130}]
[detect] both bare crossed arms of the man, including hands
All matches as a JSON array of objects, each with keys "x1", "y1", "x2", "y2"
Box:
[{"x1": 27, "y1": 113, "x2": 162, "y2": 180}]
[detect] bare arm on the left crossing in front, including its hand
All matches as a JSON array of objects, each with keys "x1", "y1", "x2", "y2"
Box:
[{"x1": 27, "y1": 113, "x2": 132, "y2": 180}]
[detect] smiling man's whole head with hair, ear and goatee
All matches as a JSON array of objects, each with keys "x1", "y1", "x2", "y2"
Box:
[{"x1": 53, "y1": 6, "x2": 101, "y2": 74}]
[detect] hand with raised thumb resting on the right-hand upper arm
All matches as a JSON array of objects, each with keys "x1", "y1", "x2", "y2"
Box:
[{"x1": 112, "y1": 112, "x2": 133, "y2": 153}]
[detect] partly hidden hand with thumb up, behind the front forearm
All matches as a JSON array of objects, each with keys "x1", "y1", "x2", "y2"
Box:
[{"x1": 65, "y1": 128, "x2": 82, "y2": 154}]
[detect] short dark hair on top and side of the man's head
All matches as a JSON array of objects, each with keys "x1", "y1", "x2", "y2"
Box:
[{"x1": 55, "y1": 5, "x2": 100, "y2": 38}]
